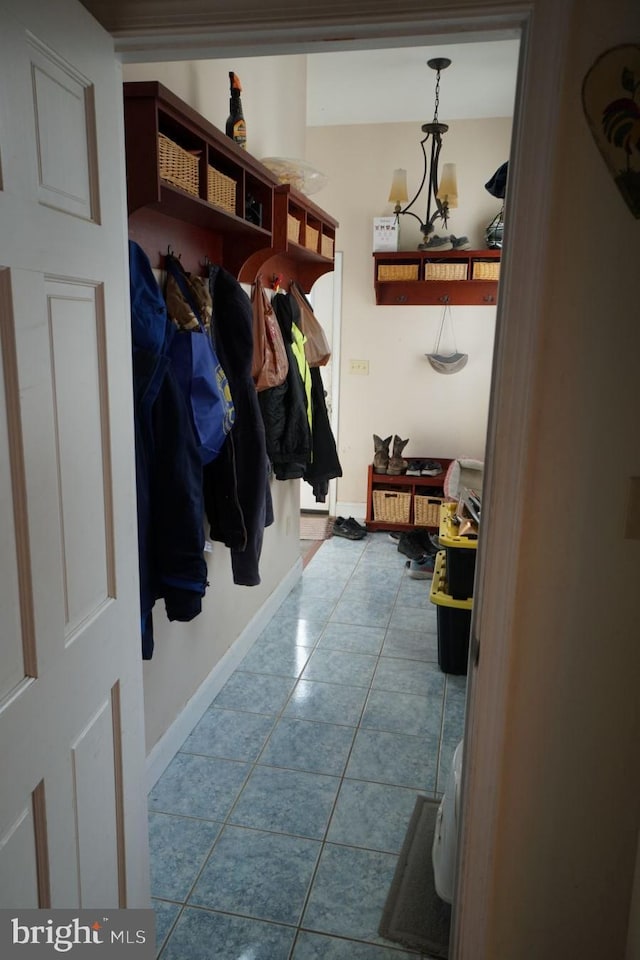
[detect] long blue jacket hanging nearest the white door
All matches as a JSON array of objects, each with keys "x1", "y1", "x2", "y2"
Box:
[{"x1": 129, "y1": 241, "x2": 207, "y2": 660}]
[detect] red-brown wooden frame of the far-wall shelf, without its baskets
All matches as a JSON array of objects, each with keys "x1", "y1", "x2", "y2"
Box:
[{"x1": 373, "y1": 249, "x2": 502, "y2": 307}]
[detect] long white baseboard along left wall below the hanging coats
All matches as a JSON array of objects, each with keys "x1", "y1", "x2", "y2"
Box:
[{"x1": 146, "y1": 558, "x2": 302, "y2": 790}]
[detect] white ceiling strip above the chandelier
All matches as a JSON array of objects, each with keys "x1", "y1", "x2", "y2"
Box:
[{"x1": 307, "y1": 40, "x2": 520, "y2": 126}]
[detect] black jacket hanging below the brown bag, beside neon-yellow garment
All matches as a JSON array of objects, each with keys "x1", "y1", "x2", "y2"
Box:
[{"x1": 258, "y1": 286, "x2": 311, "y2": 480}]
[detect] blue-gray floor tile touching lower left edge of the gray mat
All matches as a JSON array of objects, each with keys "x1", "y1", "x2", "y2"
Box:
[{"x1": 302, "y1": 844, "x2": 398, "y2": 943}]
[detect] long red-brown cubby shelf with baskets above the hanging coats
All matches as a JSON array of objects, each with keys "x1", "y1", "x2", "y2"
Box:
[{"x1": 124, "y1": 81, "x2": 338, "y2": 290}]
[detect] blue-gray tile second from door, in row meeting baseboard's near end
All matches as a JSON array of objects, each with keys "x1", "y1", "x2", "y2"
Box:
[{"x1": 229, "y1": 764, "x2": 340, "y2": 839}]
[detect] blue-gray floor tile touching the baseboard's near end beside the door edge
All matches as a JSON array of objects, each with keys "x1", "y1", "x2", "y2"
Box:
[{"x1": 149, "y1": 753, "x2": 251, "y2": 820}]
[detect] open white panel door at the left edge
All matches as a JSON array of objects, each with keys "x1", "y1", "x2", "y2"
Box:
[{"x1": 0, "y1": 0, "x2": 149, "y2": 908}]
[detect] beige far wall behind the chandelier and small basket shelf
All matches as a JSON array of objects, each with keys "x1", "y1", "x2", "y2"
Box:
[{"x1": 307, "y1": 118, "x2": 511, "y2": 504}]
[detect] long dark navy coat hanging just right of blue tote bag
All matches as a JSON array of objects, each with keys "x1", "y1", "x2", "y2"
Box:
[{"x1": 204, "y1": 265, "x2": 273, "y2": 587}]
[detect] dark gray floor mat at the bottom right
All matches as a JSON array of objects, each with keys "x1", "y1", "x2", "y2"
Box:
[{"x1": 379, "y1": 797, "x2": 451, "y2": 958}]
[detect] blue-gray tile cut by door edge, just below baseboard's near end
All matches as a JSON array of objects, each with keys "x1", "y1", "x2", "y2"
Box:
[{"x1": 149, "y1": 813, "x2": 222, "y2": 902}]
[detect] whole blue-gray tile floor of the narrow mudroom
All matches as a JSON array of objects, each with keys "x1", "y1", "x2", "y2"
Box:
[{"x1": 149, "y1": 533, "x2": 465, "y2": 960}]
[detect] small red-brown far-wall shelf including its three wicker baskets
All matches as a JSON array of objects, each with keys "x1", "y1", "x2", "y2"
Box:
[{"x1": 373, "y1": 249, "x2": 501, "y2": 307}]
